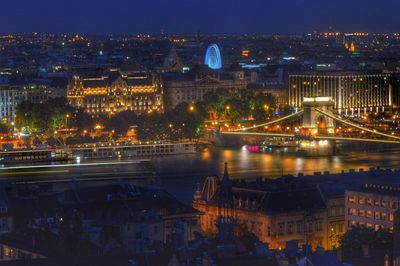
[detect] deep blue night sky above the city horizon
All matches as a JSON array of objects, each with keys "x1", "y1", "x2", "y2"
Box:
[{"x1": 0, "y1": 0, "x2": 400, "y2": 34}]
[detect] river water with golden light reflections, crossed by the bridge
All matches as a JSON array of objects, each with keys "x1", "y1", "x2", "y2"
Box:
[{"x1": 4, "y1": 147, "x2": 400, "y2": 203}]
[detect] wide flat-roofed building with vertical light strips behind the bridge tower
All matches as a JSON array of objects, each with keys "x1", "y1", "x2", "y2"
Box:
[{"x1": 289, "y1": 72, "x2": 392, "y2": 116}]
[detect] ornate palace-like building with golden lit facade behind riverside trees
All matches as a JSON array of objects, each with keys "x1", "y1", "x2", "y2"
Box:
[{"x1": 67, "y1": 71, "x2": 163, "y2": 115}]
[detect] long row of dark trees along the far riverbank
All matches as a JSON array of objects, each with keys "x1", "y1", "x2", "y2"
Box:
[{"x1": 12, "y1": 89, "x2": 286, "y2": 142}]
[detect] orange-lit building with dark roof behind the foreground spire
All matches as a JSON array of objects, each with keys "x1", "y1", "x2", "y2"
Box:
[{"x1": 193, "y1": 177, "x2": 330, "y2": 248}]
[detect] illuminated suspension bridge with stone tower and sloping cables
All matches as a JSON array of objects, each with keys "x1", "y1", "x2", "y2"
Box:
[{"x1": 221, "y1": 97, "x2": 400, "y2": 144}]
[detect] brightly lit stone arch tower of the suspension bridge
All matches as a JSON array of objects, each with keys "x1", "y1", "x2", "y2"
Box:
[{"x1": 302, "y1": 97, "x2": 335, "y2": 135}]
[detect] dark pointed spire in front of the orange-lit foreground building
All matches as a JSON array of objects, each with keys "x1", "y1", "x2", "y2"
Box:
[{"x1": 217, "y1": 162, "x2": 234, "y2": 239}]
